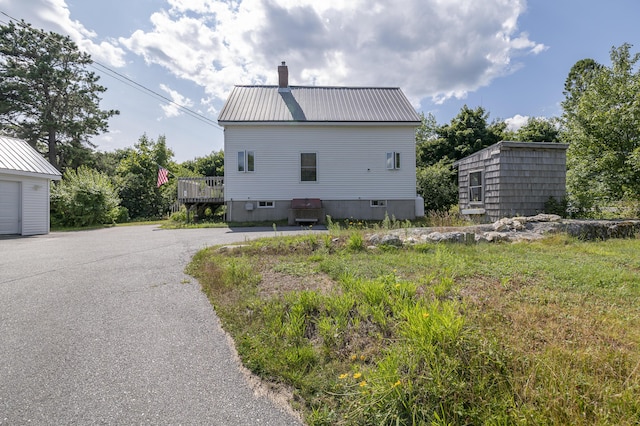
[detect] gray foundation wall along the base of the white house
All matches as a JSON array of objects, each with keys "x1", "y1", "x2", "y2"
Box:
[{"x1": 226, "y1": 199, "x2": 416, "y2": 223}]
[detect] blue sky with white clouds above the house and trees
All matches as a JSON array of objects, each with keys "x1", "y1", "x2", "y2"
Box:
[{"x1": 0, "y1": 0, "x2": 640, "y2": 161}]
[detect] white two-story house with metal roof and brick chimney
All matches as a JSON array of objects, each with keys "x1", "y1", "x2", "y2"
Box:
[{"x1": 218, "y1": 62, "x2": 422, "y2": 223}]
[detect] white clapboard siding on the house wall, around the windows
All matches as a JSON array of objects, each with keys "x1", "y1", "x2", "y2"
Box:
[{"x1": 224, "y1": 123, "x2": 416, "y2": 201}]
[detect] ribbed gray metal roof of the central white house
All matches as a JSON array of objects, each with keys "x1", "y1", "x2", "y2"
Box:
[{"x1": 218, "y1": 86, "x2": 420, "y2": 125}]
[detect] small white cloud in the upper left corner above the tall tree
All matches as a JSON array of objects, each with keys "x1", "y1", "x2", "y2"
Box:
[{"x1": 0, "y1": 0, "x2": 125, "y2": 67}]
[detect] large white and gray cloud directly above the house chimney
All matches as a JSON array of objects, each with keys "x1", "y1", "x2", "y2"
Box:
[{"x1": 120, "y1": 0, "x2": 546, "y2": 104}]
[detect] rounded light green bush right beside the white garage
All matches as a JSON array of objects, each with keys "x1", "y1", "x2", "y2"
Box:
[{"x1": 51, "y1": 166, "x2": 121, "y2": 226}]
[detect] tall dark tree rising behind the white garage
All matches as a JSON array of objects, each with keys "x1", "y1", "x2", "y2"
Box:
[{"x1": 0, "y1": 21, "x2": 118, "y2": 169}]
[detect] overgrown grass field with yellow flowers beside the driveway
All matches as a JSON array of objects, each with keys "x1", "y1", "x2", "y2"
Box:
[{"x1": 188, "y1": 230, "x2": 640, "y2": 425}]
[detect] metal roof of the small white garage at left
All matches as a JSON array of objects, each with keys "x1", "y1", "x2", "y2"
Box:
[{"x1": 0, "y1": 135, "x2": 61, "y2": 180}]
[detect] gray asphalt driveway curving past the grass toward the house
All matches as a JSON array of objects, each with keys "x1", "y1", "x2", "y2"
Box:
[{"x1": 0, "y1": 226, "x2": 316, "y2": 425}]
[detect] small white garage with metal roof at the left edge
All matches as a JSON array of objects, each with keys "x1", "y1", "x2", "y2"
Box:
[{"x1": 0, "y1": 135, "x2": 61, "y2": 235}]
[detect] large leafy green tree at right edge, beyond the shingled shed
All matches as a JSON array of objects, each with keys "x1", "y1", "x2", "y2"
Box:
[{"x1": 563, "y1": 44, "x2": 640, "y2": 211}]
